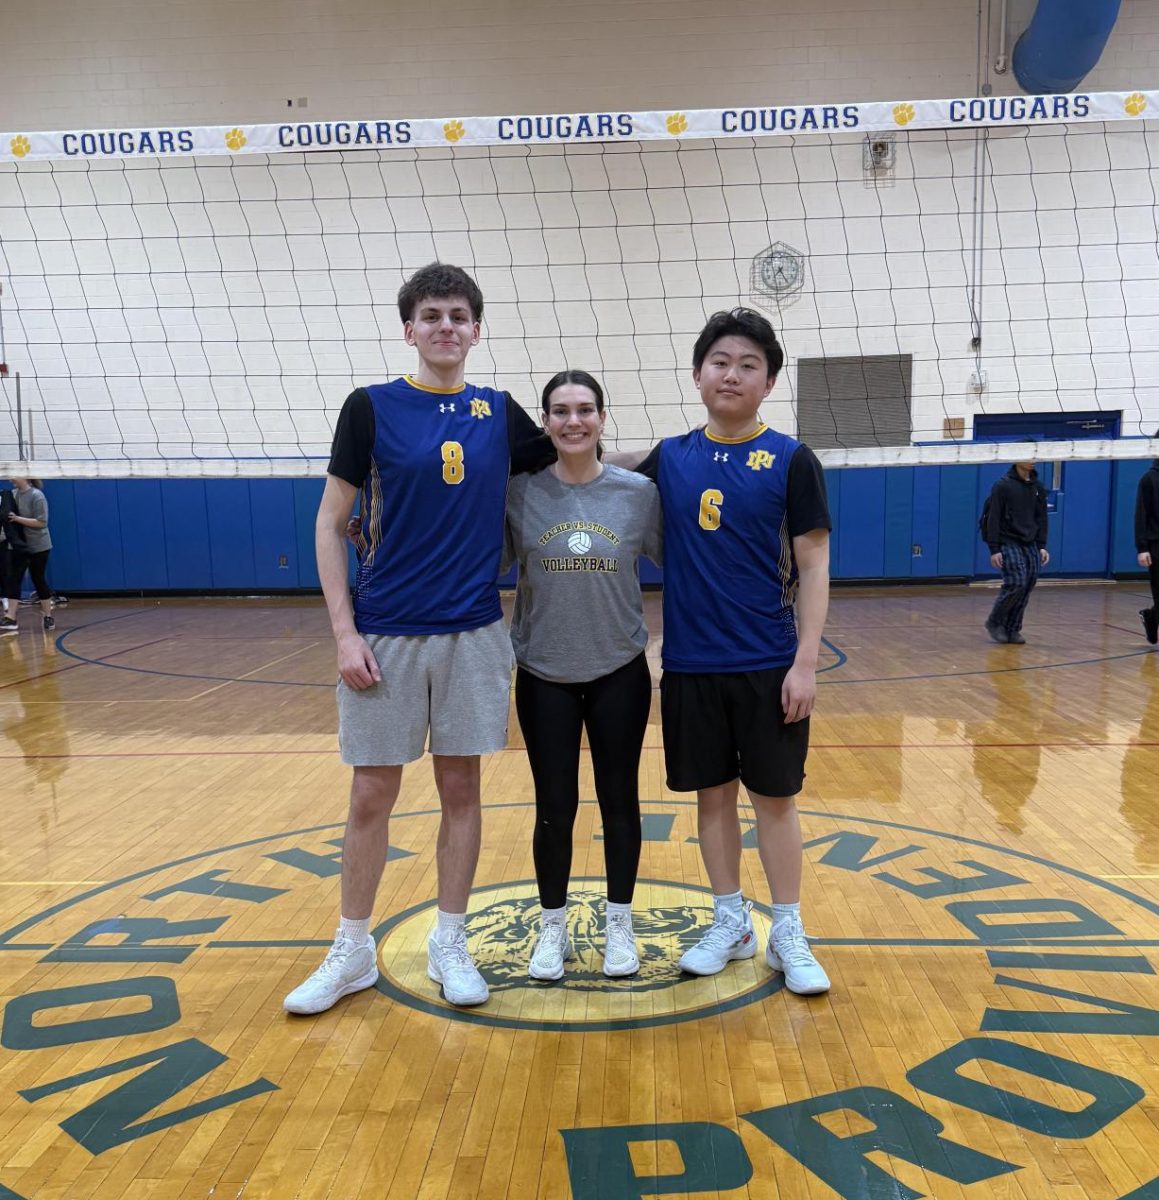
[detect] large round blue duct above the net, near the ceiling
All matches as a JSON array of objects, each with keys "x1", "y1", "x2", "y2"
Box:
[{"x1": 1011, "y1": 0, "x2": 1121, "y2": 96}]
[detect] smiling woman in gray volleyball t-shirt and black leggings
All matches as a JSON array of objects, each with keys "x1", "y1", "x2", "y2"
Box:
[{"x1": 506, "y1": 371, "x2": 661, "y2": 979}]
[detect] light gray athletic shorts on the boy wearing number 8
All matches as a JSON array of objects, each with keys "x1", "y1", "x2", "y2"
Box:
[{"x1": 338, "y1": 620, "x2": 515, "y2": 767}]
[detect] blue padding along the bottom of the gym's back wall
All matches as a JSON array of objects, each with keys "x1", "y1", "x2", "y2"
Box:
[{"x1": 31, "y1": 460, "x2": 1148, "y2": 594}]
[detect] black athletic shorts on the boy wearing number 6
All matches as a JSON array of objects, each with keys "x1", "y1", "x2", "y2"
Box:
[{"x1": 660, "y1": 667, "x2": 809, "y2": 796}]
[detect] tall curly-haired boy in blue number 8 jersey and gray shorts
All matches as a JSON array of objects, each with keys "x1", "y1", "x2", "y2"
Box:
[{"x1": 284, "y1": 263, "x2": 554, "y2": 1013}]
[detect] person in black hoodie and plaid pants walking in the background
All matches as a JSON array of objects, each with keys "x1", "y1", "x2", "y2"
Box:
[{"x1": 986, "y1": 462, "x2": 1050, "y2": 646}]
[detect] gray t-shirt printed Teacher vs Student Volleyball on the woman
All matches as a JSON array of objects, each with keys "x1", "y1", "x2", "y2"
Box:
[{"x1": 504, "y1": 464, "x2": 662, "y2": 683}]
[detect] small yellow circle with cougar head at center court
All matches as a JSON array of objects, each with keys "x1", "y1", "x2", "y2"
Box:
[{"x1": 373, "y1": 878, "x2": 785, "y2": 1032}]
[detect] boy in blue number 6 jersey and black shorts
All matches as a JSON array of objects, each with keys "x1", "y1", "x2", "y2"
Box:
[{"x1": 638, "y1": 308, "x2": 831, "y2": 995}]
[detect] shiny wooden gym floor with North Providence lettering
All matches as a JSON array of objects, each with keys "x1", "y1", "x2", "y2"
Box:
[{"x1": 0, "y1": 583, "x2": 1159, "y2": 1200}]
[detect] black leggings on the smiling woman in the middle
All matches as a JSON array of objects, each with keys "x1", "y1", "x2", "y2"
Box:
[{"x1": 515, "y1": 654, "x2": 651, "y2": 908}]
